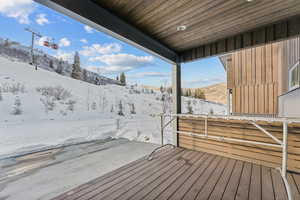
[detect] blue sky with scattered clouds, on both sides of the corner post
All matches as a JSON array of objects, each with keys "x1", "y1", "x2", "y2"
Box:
[{"x1": 0, "y1": 0, "x2": 226, "y2": 88}]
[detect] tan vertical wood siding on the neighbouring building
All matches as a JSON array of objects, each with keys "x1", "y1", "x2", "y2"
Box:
[{"x1": 227, "y1": 43, "x2": 282, "y2": 115}]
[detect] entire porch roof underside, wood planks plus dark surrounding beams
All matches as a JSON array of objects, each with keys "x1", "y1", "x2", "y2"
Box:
[{"x1": 36, "y1": 0, "x2": 300, "y2": 62}]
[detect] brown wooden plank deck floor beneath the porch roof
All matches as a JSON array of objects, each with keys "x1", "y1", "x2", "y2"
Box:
[{"x1": 54, "y1": 148, "x2": 300, "y2": 200}]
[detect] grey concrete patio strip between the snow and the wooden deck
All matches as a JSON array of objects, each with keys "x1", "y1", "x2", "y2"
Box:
[{"x1": 0, "y1": 139, "x2": 157, "y2": 200}]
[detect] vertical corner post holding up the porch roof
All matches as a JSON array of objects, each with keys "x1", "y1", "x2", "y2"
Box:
[{"x1": 172, "y1": 63, "x2": 181, "y2": 146}]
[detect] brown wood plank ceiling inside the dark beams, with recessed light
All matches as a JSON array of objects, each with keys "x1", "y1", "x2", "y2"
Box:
[{"x1": 94, "y1": 0, "x2": 300, "y2": 52}]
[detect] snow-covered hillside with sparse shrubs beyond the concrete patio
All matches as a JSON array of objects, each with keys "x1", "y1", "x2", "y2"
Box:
[{"x1": 0, "y1": 57, "x2": 226, "y2": 158}]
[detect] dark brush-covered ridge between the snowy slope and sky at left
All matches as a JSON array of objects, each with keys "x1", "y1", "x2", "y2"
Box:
[{"x1": 0, "y1": 38, "x2": 121, "y2": 85}]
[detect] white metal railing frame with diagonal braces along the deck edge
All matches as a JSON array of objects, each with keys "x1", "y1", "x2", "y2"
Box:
[{"x1": 157, "y1": 114, "x2": 300, "y2": 200}]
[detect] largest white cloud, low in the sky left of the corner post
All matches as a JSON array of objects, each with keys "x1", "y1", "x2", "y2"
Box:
[{"x1": 87, "y1": 54, "x2": 154, "y2": 75}]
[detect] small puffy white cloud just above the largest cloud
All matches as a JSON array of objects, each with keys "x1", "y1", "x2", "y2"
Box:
[{"x1": 79, "y1": 43, "x2": 122, "y2": 56}]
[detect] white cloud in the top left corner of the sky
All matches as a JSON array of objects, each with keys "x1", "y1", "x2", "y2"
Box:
[{"x1": 0, "y1": 0, "x2": 34, "y2": 24}]
